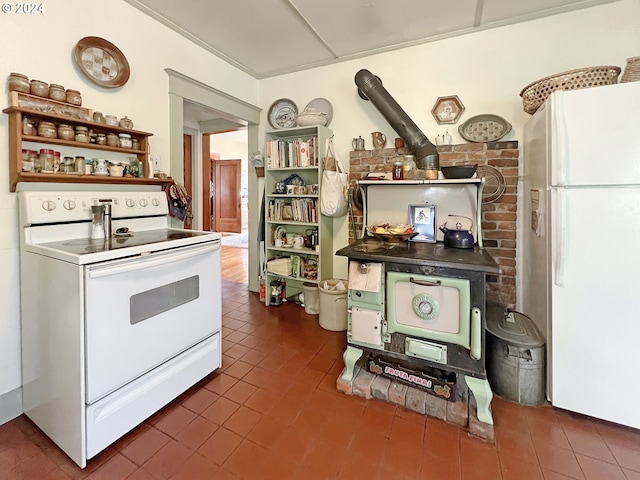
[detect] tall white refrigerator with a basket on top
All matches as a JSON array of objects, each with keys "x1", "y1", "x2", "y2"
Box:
[{"x1": 518, "y1": 82, "x2": 640, "y2": 428}]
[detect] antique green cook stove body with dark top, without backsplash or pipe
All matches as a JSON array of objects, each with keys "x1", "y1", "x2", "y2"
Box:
[{"x1": 336, "y1": 238, "x2": 499, "y2": 424}]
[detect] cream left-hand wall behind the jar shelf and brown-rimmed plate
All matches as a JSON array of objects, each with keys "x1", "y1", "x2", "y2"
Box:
[{"x1": 0, "y1": 0, "x2": 258, "y2": 416}]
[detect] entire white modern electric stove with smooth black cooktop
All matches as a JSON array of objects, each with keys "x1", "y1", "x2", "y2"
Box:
[{"x1": 18, "y1": 191, "x2": 222, "y2": 468}]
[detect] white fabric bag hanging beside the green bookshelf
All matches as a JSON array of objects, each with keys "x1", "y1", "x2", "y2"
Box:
[{"x1": 320, "y1": 137, "x2": 349, "y2": 217}]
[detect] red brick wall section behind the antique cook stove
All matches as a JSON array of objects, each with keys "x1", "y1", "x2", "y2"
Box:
[{"x1": 349, "y1": 141, "x2": 519, "y2": 308}]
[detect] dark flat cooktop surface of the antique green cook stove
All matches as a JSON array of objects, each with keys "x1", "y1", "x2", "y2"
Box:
[{"x1": 336, "y1": 237, "x2": 500, "y2": 273}]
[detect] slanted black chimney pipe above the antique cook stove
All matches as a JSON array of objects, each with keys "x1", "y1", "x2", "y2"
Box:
[{"x1": 355, "y1": 69, "x2": 438, "y2": 165}]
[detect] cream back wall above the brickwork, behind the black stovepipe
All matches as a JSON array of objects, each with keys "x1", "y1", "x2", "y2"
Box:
[{"x1": 260, "y1": 0, "x2": 640, "y2": 278}]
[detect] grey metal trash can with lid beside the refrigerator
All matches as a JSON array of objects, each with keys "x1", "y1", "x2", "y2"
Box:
[{"x1": 487, "y1": 307, "x2": 546, "y2": 405}]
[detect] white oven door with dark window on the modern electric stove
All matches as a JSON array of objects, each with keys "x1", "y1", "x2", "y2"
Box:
[{"x1": 84, "y1": 241, "x2": 222, "y2": 404}]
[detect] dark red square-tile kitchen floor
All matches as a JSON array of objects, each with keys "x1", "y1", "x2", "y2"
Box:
[{"x1": 0, "y1": 249, "x2": 640, "y2": 480}]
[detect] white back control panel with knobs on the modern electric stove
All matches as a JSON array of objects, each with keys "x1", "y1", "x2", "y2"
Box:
[{"x1": 18, "y1": 191, "x2": 169, "y2": 226}]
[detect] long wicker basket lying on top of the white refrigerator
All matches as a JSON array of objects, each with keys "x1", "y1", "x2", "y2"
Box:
[{"x1": 520, "y1": 66, "x2": 620, "y2": 114}]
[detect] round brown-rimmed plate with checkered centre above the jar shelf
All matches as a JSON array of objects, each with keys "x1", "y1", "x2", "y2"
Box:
[{"x1": 75, "y1": 37, "x2": 130, "y2": 88}]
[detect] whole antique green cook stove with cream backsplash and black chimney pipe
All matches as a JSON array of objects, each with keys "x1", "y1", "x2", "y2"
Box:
[{"x1": 336, "y1": 70, "x2": 500, "y2": 424}]
